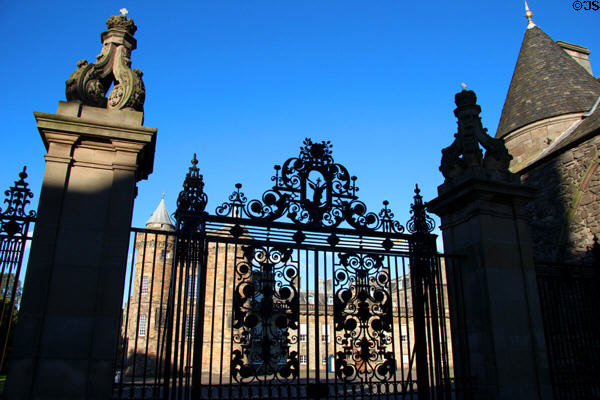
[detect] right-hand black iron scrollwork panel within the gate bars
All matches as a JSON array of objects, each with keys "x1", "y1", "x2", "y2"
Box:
[{"x1": 334, "y1": 253, "x2": 395, "y2": 381}]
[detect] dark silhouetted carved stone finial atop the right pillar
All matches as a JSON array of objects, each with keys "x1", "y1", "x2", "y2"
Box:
[{"x1": 440, "y1": 88, "x2": 512, "y2": 179}]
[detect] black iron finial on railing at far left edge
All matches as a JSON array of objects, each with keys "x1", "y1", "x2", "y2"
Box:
[{"x1": 0, "y1": 167, "x2": 36, "y2": 236}]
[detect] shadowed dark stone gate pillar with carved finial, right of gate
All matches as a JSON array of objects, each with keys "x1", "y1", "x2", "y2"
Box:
[{"x1": 428, "y1": 90, "x2": 552, "y2": 399}]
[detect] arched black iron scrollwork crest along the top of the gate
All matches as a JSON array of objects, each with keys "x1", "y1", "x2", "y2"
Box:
[{"x1": 216, "y1": 138, "x2": 404, "y2": 233}]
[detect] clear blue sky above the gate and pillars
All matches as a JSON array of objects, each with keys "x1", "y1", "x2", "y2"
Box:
[{"x1": 0, "y1": 0, "x2": 600, "y2": 234}]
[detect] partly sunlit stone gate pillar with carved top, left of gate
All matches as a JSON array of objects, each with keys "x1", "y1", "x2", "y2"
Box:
[{"x1": 6, "y1": 15, "x2": 156, "y2": 399}]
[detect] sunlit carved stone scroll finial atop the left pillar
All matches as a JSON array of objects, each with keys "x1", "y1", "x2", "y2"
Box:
[{"x1": 66, "y1": 9, "x2": 146, "y2": 111}]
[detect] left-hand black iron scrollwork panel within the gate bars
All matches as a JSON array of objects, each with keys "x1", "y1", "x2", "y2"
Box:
[{"x1": 231, "y1": 246, "x2": 299, "y2": 383}]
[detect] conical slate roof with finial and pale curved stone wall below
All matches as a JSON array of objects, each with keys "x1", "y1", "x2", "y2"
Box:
[{"x1": 496, "y1": 6, "x2": 600, "y2": 172}]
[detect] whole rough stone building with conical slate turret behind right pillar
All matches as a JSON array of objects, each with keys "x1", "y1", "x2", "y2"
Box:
[{"x1": 496, "y1": 7, "x2": 600, "y2": 262}]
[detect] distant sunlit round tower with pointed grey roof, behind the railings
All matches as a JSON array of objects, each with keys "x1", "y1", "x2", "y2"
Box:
[{"x1": 118, "y1": 195, "x2": 175, "y2": 379}]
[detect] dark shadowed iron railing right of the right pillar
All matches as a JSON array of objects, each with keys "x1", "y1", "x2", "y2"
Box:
[{"x1": 536, "y1": 248, "x2": 600, "y2": 400}]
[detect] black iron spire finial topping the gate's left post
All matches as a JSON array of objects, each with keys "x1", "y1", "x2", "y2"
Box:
[{"x1": 175, "y1": 153, "x2": 208, "y2": 230}]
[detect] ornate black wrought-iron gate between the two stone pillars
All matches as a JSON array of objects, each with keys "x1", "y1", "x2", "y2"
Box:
[{"x1": 117, "y1": 139, "x2": 454, "y2": 399}]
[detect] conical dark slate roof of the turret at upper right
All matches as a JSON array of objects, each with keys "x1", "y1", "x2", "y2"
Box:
[{"x1": 496, "y1": 21, "x2": 600, "y2": 138}]
